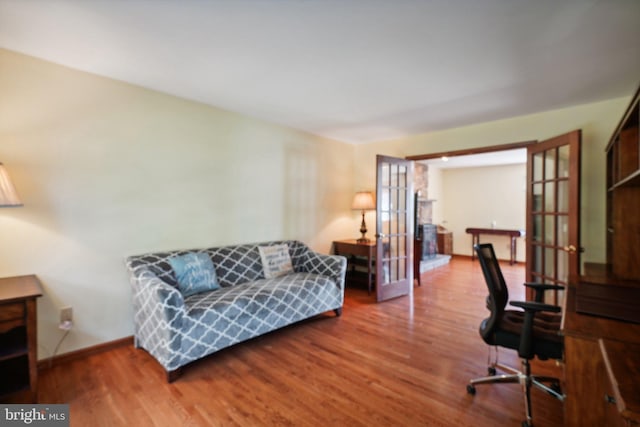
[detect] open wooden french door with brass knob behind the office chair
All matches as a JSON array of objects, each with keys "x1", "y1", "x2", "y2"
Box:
[{"x1": 526, "y1": 130, "x2": 581, "y2": 305}]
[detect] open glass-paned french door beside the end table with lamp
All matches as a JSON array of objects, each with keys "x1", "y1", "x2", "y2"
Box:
[{"x1": 376, "y1": 155, "x2": 414, "y2": 302}]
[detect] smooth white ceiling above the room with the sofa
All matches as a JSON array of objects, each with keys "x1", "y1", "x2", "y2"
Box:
[{"x1": 0, "y1": 0, "x2": 640, "y2": 143}]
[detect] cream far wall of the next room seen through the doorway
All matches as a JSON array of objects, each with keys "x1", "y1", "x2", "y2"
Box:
[{"x1": 442, "y1": 164, "x2": 527, "y2": 261}]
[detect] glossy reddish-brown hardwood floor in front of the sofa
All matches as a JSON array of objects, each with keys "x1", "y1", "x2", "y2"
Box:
[{"x1": 39, "y1": 258, "x2": 562, "y2": 427}]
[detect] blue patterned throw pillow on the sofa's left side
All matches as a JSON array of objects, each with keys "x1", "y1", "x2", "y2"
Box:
[{"x1": 169, "y1": 253, "x2": 220, "y2": 297}]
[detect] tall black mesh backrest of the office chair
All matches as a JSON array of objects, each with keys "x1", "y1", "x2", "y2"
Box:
[{"x1": 474, "y1": 243, "x2": 509, "y2": 341}]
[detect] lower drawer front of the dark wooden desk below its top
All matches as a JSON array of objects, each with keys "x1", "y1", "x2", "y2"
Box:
[{"x1": 562, "y1": 283, "x2": 640, "y2": 427}]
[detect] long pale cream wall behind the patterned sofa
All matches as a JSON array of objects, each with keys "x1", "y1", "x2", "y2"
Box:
[{"x1": 0, "y1": 49, "x2": 359, "y2": 358}]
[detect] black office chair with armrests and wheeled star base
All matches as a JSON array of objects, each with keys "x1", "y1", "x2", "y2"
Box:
[{"x1": 467, "y1": 243, "x2": 564, "y2": 427}]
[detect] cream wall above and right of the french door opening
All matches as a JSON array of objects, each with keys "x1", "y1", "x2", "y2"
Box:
[{"x1": 355, "y1": 98, "x2": 631, "y2": 270}]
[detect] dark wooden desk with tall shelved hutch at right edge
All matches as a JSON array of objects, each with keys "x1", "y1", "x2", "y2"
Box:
[{"x1": 562, "y1": 83, "x2": 640, "y2": 427}]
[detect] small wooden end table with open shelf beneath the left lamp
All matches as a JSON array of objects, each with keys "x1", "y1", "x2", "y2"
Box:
[{"x1": 0, "y1": 275, "x2": 42, "y2": 403}]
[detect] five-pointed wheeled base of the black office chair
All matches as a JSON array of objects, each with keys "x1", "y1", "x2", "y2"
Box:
[{"x1": 467, "y1": 359, "x2": 565, "y2": 427}]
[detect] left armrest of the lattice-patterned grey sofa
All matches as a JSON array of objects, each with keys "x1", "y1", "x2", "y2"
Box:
[{"x1": 128, "y1": 265, "x2": 185, "y2": 369}]
